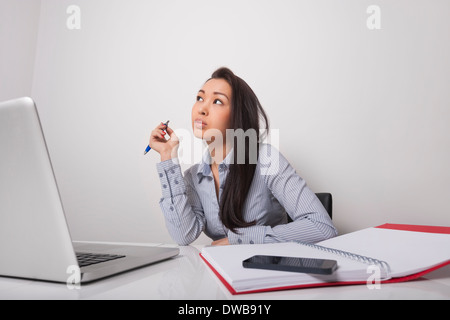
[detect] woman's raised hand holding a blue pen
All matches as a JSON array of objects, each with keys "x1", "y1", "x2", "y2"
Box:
[{"x1": 148, "y1": 123, "x2": 180, "y2": 161}]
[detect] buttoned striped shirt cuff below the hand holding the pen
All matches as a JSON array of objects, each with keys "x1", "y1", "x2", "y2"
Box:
[{"x1": 156, "y1": 159, "x2": 186, "y2": 199}]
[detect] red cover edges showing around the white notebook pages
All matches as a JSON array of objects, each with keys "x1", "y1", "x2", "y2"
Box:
[{"x1": 200, "y1": 223, "x2": 450, "y2": 295}]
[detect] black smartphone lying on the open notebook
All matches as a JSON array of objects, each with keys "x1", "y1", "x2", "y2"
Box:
[{"x1": 242, "y1": 255, "x2": 337, "y2": 275}]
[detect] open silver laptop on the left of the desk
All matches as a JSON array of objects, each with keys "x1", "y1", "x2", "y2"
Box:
[{"x1": 0, "y1": 98, "x2": 179, "y2": 284}]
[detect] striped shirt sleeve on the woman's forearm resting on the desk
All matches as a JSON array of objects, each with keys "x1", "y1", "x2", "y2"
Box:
[{"x1": 228, "y1": 145, "x2": 337, "y2": 244}]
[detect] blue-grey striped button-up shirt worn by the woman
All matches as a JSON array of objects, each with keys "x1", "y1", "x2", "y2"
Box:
[{"x1": 157, "y1": 144, "x2": 337, "y2": 245}]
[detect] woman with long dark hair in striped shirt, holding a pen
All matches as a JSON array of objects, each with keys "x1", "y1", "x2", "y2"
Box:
[{"x1": 149, "y1": 68, "x2": 337, "y2": 245}]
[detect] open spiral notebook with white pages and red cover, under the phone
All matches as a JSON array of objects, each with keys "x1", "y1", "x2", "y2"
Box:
[{"x1": 200, "y1": 224, "x2": 450, "y2": 294}]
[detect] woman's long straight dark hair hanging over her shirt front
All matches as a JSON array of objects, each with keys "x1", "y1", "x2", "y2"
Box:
[{"x1": 211, "y1": 68, "x2": 269, "y2": 233}]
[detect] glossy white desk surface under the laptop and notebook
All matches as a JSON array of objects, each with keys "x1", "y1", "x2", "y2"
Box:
[{"x1": 0, "y1": 246, "x2": 450, "y2": 300}]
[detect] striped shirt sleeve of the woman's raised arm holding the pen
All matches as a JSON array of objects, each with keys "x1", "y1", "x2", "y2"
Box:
[{"x1": 156, "y1": 159, "x2": 205, "y2": 245}]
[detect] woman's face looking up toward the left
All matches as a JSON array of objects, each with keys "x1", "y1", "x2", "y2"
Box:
[{"x1": 192, "y1": 79, "x2": 232, "y2": 142}]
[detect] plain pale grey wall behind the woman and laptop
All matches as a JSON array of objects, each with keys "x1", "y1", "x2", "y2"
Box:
[{"x1": 0, "y1": 0, "x2": 450, "y2": 243}]
